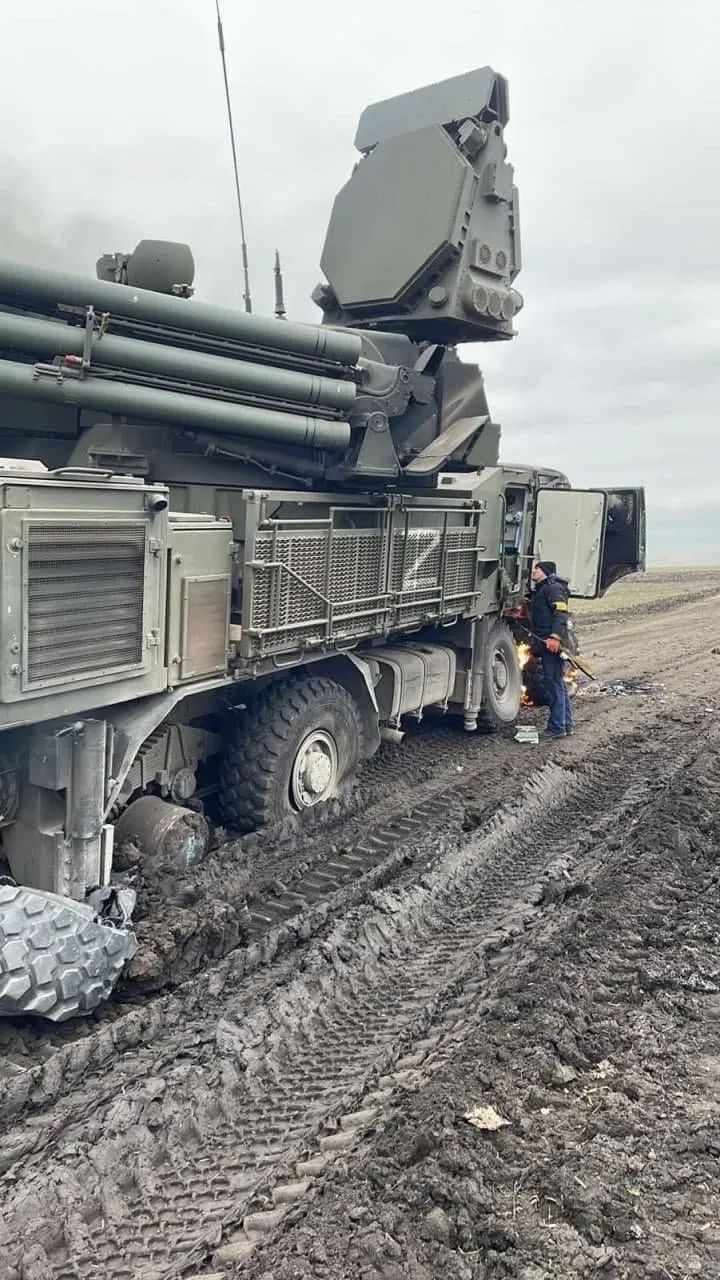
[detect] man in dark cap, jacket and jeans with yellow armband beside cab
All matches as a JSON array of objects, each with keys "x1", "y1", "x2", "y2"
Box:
[{"x1": 530, "y1": 561, "x2": 573, "y2": 739}]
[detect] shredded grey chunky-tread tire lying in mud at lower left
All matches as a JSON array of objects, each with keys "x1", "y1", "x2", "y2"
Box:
[{"x1": 0, "y1": 882, "x2": 137, "y2": 1023}]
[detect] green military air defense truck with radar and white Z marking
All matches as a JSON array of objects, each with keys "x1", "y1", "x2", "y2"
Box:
[{"x1": 0, "y1": 68, "x2": 644, "y2": 1020}]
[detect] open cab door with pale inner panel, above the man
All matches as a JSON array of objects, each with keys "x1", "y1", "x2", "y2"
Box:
[{"x1": 533, "y1": 489, "x2": 646, "y2": 600}]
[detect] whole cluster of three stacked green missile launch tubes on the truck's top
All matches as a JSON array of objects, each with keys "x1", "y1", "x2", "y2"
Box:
[{"x1": 0, "y1": 254, "x2": 360, "y2": 451}]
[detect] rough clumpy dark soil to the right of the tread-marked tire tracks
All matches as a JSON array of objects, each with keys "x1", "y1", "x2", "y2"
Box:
[{"x1": 237, "y1": 726, "x2": 720, "y2": 1280}]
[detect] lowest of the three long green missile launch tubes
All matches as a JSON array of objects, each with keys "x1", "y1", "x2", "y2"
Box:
[{"x1": 0, "y1": 360, "x2": 350, "y2": 449}]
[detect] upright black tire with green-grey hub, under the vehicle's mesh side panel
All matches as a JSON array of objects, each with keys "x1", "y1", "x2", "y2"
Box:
[{"x1": 219, "y1": 676, "x2": 363, "y2": 831}]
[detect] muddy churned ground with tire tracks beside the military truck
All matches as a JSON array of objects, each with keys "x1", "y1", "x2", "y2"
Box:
[{"x1": 0, "y1": 583, "x2": 720, "y2": 1280}]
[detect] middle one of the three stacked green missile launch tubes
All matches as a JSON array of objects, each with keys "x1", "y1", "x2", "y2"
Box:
[{"x1": 0, "y1": 311, "x2": 355, "y2": 411}]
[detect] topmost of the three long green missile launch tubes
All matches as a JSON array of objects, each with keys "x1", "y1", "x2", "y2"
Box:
[{"x1": 0, "y1": 259, "x2": 360, "y2": 365}]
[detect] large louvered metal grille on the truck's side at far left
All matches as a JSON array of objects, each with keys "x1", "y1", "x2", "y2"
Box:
[{"x1": 26, "y1": 521, "x2": 146, "y2": 685}]
